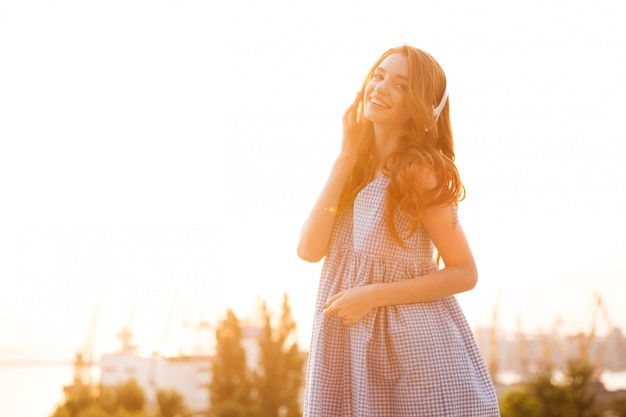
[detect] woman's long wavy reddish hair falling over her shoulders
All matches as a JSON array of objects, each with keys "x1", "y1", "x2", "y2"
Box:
[{"x1": 340, "y1": 45, "x2": 465, "y2": 244}]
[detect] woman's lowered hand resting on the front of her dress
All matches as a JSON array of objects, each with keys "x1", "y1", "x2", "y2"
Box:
[{"x1": 324, "y1": 285, "x2": 374, "y2": 325}]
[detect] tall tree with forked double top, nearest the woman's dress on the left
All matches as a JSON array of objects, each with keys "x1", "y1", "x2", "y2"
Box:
[{"x1": 255, "y1": 294, "x2": 304, "y2": 417}]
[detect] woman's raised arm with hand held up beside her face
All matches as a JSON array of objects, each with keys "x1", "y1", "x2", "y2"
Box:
[{"x1": 298, "y1": 95, "x2": 361, "y2": 262}]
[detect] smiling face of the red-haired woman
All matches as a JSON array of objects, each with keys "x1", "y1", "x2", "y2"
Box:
[{"x1": 363, "y1": 53, "x2": 410, "y2": 126}]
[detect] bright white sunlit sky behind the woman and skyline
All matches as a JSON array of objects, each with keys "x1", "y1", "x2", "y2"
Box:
[{"x1": 0, "y1": 0, "x2": 626, "y2": 359}]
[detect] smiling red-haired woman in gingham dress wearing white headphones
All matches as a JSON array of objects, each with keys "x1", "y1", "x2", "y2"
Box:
[{"x1": 298, "y1": 46, "x2": 499, "y2": 417}]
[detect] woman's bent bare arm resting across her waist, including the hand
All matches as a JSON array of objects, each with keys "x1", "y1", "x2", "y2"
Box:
[{"x1": 324, "y1": 206, "x2": 478, "y2": 324}]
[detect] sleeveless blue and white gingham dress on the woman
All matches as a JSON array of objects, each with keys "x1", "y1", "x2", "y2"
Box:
[{"x1": 304, "y1": 177, "x2": 500, "y2": 417}]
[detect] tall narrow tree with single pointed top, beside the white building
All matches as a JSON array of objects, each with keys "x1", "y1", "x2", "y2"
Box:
[{"x1": 209, "y1": 310, "x2": 253, "y2": 417}]
